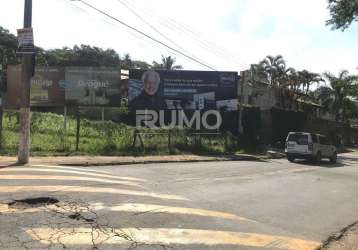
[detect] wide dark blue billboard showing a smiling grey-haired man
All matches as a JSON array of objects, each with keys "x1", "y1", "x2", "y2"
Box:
[{"x1": 128, "y1": 69, "x2": 238, "y2": 110}]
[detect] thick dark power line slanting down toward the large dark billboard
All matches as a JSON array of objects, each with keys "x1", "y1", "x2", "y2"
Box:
[{"x1": 71, "y1": 0, "x2": 217, "y2": 71}]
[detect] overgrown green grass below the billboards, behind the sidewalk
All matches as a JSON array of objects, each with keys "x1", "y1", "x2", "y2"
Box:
[{"x1": 0, "y1": 112, "x2": 241, "y2": 156}]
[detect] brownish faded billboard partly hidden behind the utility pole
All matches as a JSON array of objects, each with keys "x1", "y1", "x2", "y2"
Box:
[{"x1": 4, "y1": 65, "x2": 65, "y2": 108}]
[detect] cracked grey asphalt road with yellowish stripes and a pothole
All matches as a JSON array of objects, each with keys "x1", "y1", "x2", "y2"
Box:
[{"x1": 0, "y1": 153, "x2": 358, "y2": 250}]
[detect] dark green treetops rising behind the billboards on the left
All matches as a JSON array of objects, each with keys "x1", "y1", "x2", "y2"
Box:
[{"x1": 0, "y1": 26, "x2": 183, "y2": 76}]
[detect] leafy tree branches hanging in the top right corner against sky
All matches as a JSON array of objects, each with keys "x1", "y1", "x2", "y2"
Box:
[{"x1": 326, "y1": 0, "x2": 358, "y2": 31}]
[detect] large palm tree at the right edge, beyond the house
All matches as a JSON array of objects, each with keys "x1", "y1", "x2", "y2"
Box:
[{"x1": 316, "y1": 70, "x2": 358, "y2": 122}]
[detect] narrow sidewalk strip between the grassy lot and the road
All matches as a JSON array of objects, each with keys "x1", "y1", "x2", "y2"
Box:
[{"x1": 0, "y1": 154, "x2": 265, "y2": 168}]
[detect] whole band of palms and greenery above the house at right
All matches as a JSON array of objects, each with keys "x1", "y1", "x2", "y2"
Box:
[{"x1": 250, "y1": 55, "x2": 358, "y2": 122}]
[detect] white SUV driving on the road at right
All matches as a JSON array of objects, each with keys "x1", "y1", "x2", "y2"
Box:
[{"x1": 285, "y1": 132, "x2": 337, "y2": 163}]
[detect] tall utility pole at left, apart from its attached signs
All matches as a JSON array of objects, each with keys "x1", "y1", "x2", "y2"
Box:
[{"x1": 17, "y1": 0, "x2": 34, "y2": 164}]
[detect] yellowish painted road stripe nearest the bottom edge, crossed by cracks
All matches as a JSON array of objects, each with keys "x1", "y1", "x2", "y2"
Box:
[{"x1": 26, "y1": 228, "x2": 320, "y2": 250}]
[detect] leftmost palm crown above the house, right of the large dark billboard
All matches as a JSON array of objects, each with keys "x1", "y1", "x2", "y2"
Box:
[{"x1": 259, "y1": 55, "x2": 286, "y2": 86}]
